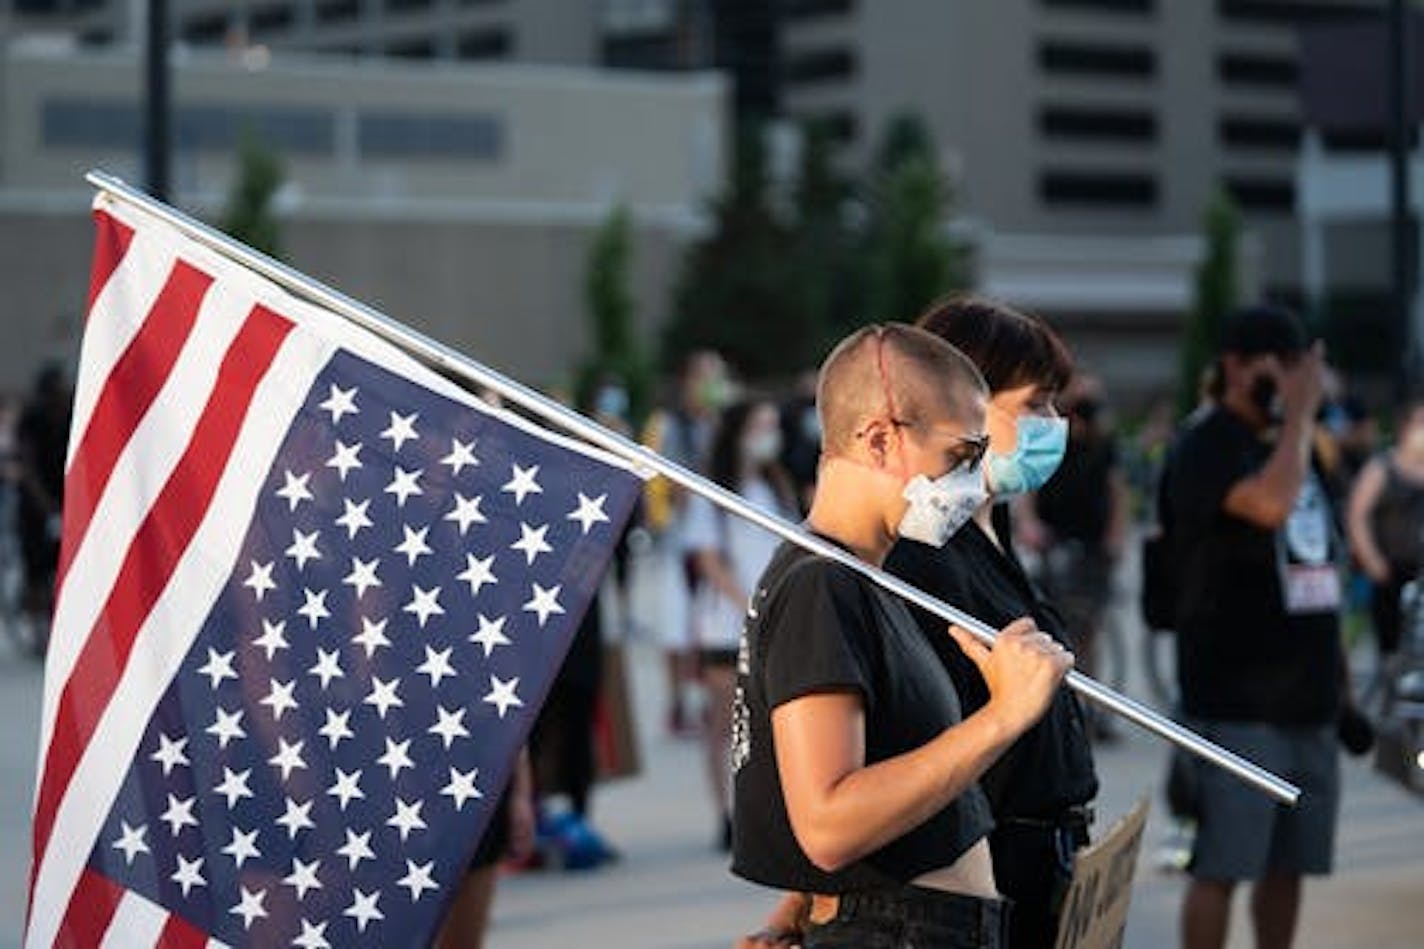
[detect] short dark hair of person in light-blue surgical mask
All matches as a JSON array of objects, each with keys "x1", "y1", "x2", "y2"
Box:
[{"x1": 914, "y1": 294, "x2": 1072, "y2": 393}]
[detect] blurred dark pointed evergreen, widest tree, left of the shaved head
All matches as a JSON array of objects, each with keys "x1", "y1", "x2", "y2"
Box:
[{"x1": 662, "y1": 125, "x2": 819, "y2": 379}]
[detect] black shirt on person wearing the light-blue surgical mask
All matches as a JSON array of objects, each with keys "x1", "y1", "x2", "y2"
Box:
[{"x1": 886, "y1": 522, "x2": 1098, "y2": 819}]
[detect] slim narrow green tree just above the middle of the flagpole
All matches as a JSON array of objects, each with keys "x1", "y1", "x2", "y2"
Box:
[{"x1": 574, "y1": 205, "x2": 652, "y2": 427}]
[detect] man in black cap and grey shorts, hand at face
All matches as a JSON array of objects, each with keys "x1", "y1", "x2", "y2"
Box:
[{"x1": 1163, "y1": 308, "x2": 1343, "y2": 949}]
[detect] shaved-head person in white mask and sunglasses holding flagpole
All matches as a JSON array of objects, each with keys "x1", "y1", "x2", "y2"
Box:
[{"x1": 732, "y1": 325, "x2": 1072, "y2": 948}]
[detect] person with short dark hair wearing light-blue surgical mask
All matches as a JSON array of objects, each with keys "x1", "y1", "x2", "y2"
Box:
[{"x1": 886, "y1": 296, "x2": 1098, "y2": 949}]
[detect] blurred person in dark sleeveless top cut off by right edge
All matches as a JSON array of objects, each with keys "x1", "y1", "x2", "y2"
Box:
[{"x1": 1346, "y1": 393, "x2": 1424, "y2": 690}]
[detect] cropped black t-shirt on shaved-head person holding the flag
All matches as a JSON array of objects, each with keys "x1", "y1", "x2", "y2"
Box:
[{"x1": 732, "y1": 544, "x2": 993, "y2": 893}]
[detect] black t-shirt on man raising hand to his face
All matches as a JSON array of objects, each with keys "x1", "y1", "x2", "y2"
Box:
[{"x1": 1166, "y1": 408, "x2": 1341, "y2": 725}]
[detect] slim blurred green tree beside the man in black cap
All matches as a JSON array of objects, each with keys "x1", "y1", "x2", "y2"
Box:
[{"x1": 1176, "y1": 191, "x2": 1242, "y2": 415}]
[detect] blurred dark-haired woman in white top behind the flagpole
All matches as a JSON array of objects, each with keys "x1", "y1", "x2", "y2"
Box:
[{"x1": 684, "y1": 399, "x2": 796, "y2": 851}]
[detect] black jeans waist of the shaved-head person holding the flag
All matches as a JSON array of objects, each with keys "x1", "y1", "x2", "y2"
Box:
[{"x1": 802, "y1": 886, "x2": 1008, "y2": 949}]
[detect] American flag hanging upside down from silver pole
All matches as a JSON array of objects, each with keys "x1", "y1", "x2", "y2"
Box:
[{"x1": 26, "y1": 197, "x2": 638, "y2": 949}]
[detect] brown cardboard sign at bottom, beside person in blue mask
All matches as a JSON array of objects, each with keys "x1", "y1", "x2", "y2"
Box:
[{"x1": 1055, "y1": 798, "x2": 1149, "y2": 949}]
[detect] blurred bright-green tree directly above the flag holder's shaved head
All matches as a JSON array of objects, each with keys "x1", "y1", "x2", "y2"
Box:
[{"x1": 864, "y1": 115, "x2": 970, "y2": 321}]
